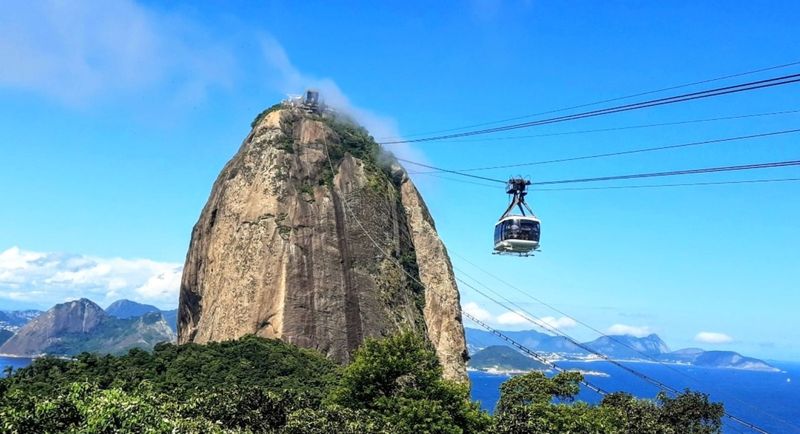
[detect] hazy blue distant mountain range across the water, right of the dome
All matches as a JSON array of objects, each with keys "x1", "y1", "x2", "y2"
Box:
[{"x1": 465, "y1": 328, "x2": 778, "y2": 371}]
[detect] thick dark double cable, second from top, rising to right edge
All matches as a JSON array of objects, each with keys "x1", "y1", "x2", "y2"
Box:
[{"x1": 382, "y1": 74, "x2": 800, "y2": 145}]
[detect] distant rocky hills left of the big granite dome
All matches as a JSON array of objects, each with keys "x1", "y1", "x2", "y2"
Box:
[{"x1": 0, "y1": 298, "x2": 175, "y2": 356}]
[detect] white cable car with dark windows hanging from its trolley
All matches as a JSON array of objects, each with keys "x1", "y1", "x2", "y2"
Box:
[{"x1": 493, "y1": 178, "x2": 541, "y2": 256}]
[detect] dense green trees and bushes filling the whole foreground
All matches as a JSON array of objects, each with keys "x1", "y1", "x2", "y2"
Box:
[{"x1": 0, "y1": 332, "x2": 723, "y2": 434}]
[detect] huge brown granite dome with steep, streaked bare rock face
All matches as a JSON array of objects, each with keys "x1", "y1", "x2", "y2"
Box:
[{"x1": 178, "y1": 106, "x2": 466, "y2": 381}]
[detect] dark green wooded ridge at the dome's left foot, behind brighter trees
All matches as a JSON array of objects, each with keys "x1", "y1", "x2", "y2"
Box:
[{"x1": 4, "y1": 336, "x2": 338, "y2": 399}]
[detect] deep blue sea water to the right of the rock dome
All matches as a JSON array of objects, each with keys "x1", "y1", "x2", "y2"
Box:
[{"x1": 469, "y1": 362, "x2": 800, "y2": 434}]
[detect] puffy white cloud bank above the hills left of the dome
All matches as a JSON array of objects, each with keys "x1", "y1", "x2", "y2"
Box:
[{"x1": 0, "y1": 247, "x2": 182, "y2": 308}]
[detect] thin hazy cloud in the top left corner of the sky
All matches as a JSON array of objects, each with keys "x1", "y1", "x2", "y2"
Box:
[{"x1": 0, "y1": 0, "x2": 233, "y2": 105}]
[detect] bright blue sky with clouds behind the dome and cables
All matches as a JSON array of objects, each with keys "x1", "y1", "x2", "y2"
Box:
[{"x1": 0, "y1": 1, "x2": 800, "y2": 360}]
